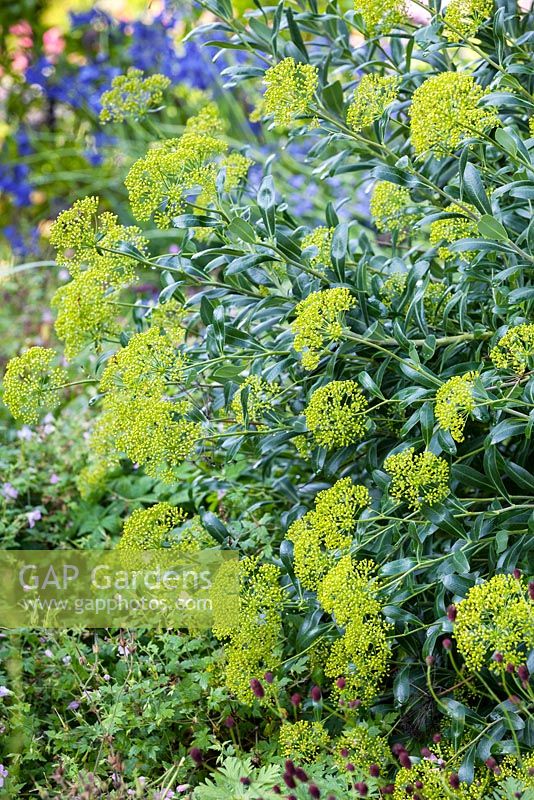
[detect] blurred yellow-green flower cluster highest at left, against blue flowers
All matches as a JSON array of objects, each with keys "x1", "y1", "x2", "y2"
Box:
[{"x1": 100, "y1": 67, "x2": 171, "y2": 124}]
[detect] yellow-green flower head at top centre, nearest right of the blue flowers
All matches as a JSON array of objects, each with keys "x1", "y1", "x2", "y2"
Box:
[{"x1": 263, "y1": 58, "x2": 319, "y2": 126}]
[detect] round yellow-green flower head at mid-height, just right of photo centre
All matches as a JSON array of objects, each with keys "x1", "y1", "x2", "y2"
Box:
[{"x1": 304, "y1": 381, "x2": 369, "y2": 450}]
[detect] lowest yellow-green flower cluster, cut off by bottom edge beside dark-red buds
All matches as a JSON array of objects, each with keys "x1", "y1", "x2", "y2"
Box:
[{"x1": 393, "y1": 758, "x2": 493, "y2": 800}]
